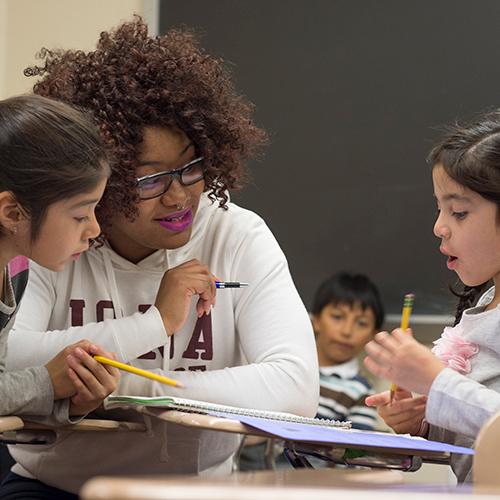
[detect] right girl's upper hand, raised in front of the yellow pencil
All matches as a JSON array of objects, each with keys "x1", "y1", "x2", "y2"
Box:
[{"x1": 364, "y1": 328, "x2": 445, "y2": 394}]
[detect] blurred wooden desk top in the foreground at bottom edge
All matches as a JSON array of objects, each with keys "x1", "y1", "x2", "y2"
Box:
[{"x1": 80, "y1": 469, "x2": 498, "y2": 500}]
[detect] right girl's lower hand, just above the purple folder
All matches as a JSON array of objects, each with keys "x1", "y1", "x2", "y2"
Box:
[{"x1": 365, "y1": 388, "x2": 427, "y2": 435}]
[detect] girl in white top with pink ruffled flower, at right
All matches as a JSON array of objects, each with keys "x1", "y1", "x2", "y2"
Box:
[{"x1": 366, "y1": 112, "x2": 500, "y2": 482}]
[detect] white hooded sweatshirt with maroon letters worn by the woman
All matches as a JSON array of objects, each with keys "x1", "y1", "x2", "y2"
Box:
[{"x1": 7, "y1": 195, "x2": 319, "y2": 493}]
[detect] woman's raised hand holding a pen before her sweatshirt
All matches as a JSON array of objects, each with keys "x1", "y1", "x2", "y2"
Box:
[{"x1": 155, "y1": 259, "x2": 216, "y2": 336}]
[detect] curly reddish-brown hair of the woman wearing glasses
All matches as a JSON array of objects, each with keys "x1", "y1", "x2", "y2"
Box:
[{"x1": 24, "y1": 16, "x2": 267, "y2": 229}]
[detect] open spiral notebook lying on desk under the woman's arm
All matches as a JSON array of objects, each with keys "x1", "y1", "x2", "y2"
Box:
[{"x1": 106, "y1": 396, "x2": 351, "y2": 429}]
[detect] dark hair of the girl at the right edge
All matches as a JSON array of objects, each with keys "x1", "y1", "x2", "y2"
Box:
[{"x1": 427, "y1": 111, "x2": 500, "y2": 325}]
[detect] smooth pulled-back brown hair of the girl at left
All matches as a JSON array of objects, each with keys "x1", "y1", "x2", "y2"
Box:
[{"x1": 0, "y1": 95, "x2": 109, "y2": 240}]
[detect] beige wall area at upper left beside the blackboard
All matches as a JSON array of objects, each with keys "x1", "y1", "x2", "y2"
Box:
[{"x1": 0, "y1": 0, "x2": 158, "y2": 99}]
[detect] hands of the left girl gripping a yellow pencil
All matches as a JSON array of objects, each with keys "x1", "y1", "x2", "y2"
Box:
[{"x1": 67, "y1": 345, "x2": 120, "y2": 415}]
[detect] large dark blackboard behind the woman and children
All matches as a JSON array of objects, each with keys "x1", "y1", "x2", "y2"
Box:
[{"x1": 160, "y1": 0, "x2": 500, "y2": 326}]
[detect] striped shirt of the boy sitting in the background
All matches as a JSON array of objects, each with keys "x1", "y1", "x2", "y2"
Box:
[{"x1": 316, "y1": 358, "x2": 377, "y2": 430}]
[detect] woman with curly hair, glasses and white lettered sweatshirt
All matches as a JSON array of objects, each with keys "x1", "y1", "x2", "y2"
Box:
[{"x1": 0, "y1": 18, "x2": 318, "y2": 498}]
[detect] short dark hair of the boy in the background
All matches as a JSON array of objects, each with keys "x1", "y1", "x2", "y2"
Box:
[{"x1": 311, "y1": 272, "x2": 384, "y2": 330}]
